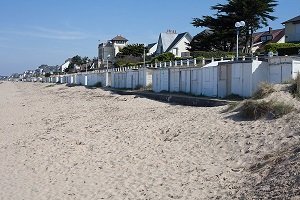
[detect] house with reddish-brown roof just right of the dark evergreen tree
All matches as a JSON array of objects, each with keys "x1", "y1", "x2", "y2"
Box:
[{"x1": 252, "y1": 27, "x2": 285, "y2": 52}]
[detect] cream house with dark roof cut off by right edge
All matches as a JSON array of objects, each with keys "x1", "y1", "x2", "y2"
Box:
[{"x1": 282, "y1": 15, "x2": 300, "y2": 42}]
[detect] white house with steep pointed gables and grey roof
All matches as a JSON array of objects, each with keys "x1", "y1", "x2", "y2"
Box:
[{"x1": 155, "y1": 30, "x2": 192, "y2": 57}]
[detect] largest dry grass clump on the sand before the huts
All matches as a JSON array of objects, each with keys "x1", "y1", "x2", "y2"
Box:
[{"x1": 240, "y1": 100, "x2": 294, "y2": 120}]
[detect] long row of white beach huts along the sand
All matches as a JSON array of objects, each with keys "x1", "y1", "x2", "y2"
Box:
[{"x1": 42, "y1": 56, "x2": 300, "y2": 98}]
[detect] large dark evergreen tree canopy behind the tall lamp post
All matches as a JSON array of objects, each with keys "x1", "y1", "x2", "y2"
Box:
[{"x1": 189, "y1": 0, "x2": 278, "y2": 52}]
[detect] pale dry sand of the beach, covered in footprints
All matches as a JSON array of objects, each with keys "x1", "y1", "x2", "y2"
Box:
[{"x1": 0, "y1": 82, "x2": 300, "y2": 200}]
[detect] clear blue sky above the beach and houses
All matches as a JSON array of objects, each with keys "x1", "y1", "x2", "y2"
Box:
[{"x1": 0, "y1": 0, "x2": 300, "y2": 75}]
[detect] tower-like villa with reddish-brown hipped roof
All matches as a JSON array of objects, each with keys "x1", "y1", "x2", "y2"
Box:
[{"x1": 98, "y1": 35, "x2": 128, "y2": 64}]
